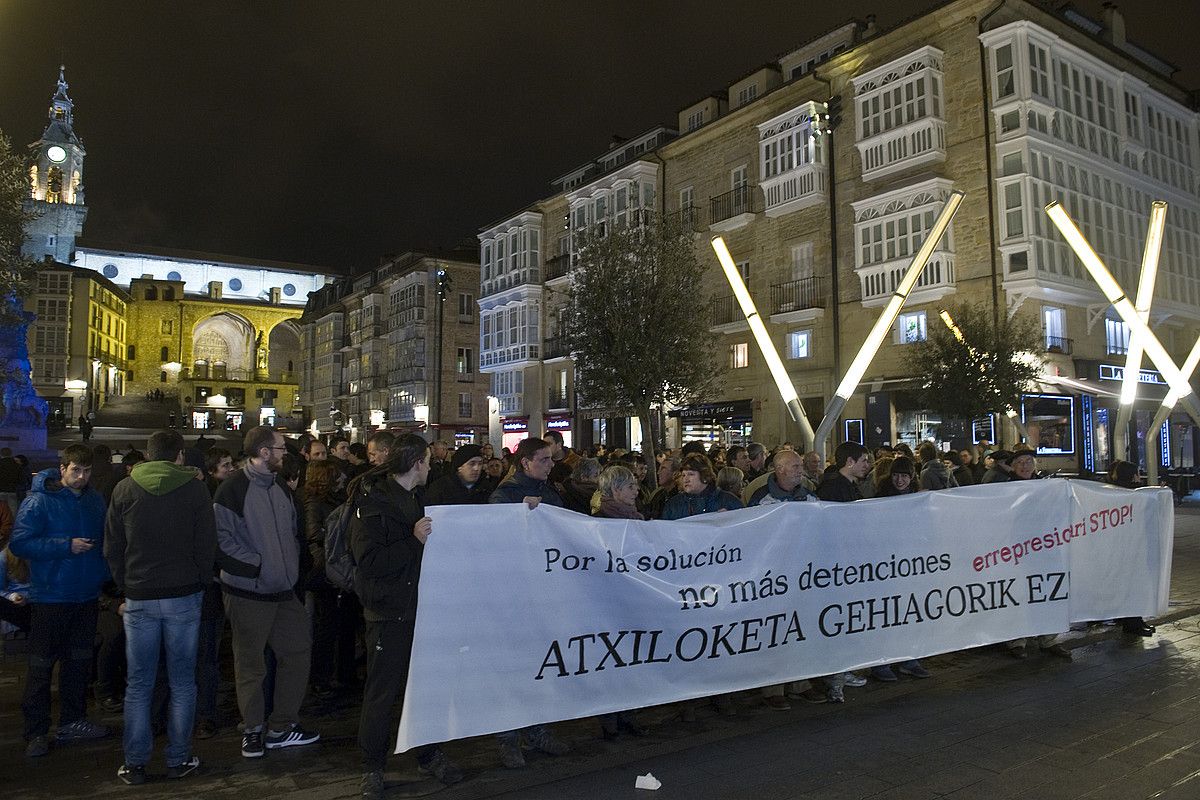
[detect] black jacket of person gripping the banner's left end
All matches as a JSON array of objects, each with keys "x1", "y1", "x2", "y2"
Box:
[{"x1": 349, "y1": 479, "x2": 425, "y2": 622}]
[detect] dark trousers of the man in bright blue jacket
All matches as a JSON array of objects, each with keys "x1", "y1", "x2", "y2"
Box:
[{"x1": 20, "y1": 600, "x2": 97, "y2": 740}]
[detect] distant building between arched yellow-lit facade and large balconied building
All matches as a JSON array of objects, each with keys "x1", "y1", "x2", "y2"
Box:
[{"x1": 300, "y1": 249, "x2": 488, "y2": 441}]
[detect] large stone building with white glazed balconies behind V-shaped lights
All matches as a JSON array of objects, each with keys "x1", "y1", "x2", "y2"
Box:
[{"x1": 480, "y1": 0, "x2": 1200, "y2": 470}]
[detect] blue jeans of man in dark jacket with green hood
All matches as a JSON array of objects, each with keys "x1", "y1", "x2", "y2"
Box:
[{"x1": 125, "y1": 591, "x2": 204, "y2": 766}]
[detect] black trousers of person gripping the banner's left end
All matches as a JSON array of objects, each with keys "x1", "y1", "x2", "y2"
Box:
[{"x1": 359, "y1": 620, "x2": 438, "y2": 772}]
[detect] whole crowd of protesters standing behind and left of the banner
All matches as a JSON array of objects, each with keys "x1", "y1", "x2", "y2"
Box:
[{"x1": 0, "y1": 427, "x2": 1153, "y2": 800}]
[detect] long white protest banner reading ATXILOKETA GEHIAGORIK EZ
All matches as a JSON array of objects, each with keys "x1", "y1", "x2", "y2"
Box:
[{"x1": 397, "y1": 480, "x2": 1175, "y2": 752}]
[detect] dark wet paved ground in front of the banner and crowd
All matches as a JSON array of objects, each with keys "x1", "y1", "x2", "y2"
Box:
[{"x1": 7, "y1": 503, "x2": 1200, "y2": 800}]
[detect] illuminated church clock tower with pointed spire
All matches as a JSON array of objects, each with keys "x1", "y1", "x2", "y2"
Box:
[{"x1": 23, "y1": 67, "x2": 88, "y2": 264}]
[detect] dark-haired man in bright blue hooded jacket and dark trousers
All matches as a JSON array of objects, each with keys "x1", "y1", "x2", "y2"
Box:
[{"x1": 10, "y1": 445, "x2": 108, "y2": 757}]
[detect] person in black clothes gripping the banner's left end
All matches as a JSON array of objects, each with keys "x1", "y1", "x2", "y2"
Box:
[{"x1": 349, "y1": 434, "x2": 463, "y2": 800}]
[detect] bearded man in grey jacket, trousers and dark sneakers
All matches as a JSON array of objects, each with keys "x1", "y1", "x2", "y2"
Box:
[{"x1": 212, "y1": 426, "x2": 320, "y2": 758}]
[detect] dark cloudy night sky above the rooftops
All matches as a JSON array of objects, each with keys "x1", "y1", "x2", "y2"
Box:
[{"x1": 0, "y1": 0, "x2": 1200, "y2": 271}]
